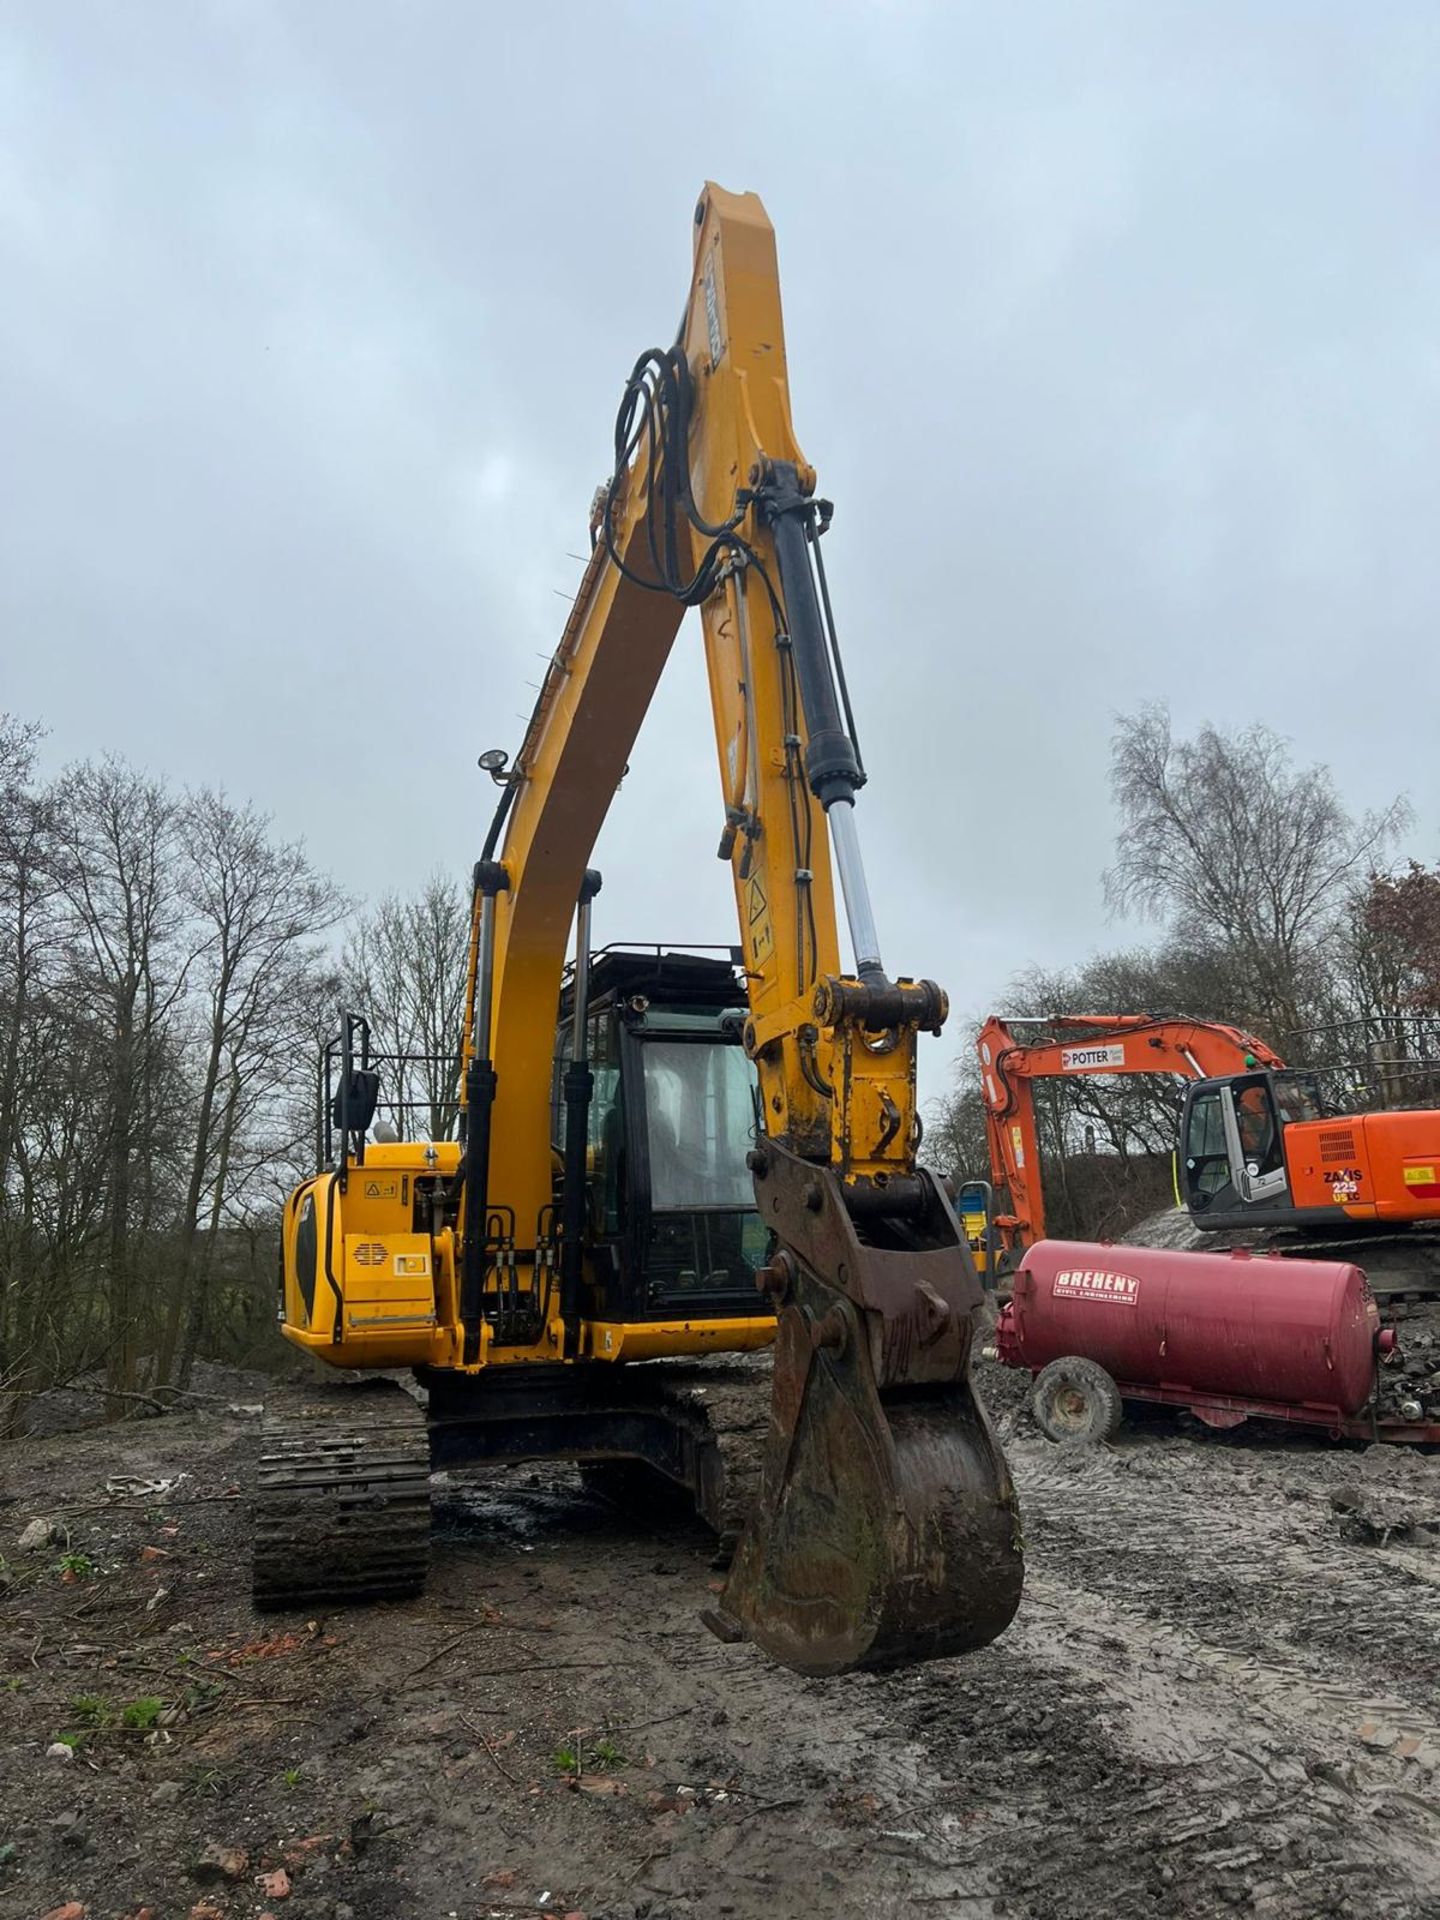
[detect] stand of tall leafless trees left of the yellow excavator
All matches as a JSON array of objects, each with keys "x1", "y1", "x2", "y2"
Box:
[{"x1": 0, "y1": 716, "x2": 359, "y2": 1430}]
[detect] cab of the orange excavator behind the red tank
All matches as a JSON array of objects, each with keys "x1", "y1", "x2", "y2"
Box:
[{"x1": 1179, "y1": 1069, "x2": 1325, "y2": 1227}]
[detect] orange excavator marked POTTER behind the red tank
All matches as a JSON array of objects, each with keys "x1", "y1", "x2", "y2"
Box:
[{"x1": 975, "y1": 1014, "x2": 1440, "y2": 1290}]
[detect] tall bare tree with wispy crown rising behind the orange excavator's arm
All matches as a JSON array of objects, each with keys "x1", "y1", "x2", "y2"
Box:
[{"x1": 1106, "y1": 705, "x2": 1409, "y2": 1044}]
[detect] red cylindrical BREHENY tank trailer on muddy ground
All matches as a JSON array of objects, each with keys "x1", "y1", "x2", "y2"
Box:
[{"x1": 995, "y1": 1240, "x2": 1440, "y2": 1442}]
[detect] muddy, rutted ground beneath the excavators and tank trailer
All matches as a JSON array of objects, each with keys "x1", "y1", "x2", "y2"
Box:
[{"x1": 0, "y1": 1369, "x2": 1440, "y2": 1920}]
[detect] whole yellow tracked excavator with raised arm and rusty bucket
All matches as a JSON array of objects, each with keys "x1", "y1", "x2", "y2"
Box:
[{"x1": 253, "y1": 186, "x2": 1021, "y2": 1674}]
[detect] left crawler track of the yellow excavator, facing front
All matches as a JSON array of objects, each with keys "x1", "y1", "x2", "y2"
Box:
[{"x1": 252, "y1": 1379, "x2": 430, "y2": 1609}]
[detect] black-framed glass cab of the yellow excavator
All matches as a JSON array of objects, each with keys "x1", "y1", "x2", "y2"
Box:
[{"x1": 551, "y1": 947, "x2": 770, "y2": 1323}]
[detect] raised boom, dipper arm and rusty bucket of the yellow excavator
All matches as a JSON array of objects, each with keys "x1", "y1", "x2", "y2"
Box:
[{"x1": 461, "y1": 186, "x2": 1021, "y2": 1672}]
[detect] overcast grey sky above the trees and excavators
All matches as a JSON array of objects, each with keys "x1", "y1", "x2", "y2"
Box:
[{"x1": 0, "y1": 0, "x2": 1440, "y2": 1092}]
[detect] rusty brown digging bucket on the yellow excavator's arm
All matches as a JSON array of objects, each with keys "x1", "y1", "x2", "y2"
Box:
[{"x1": 708, "y1": 1146, "x2": 1023, "y2": 1674}]
